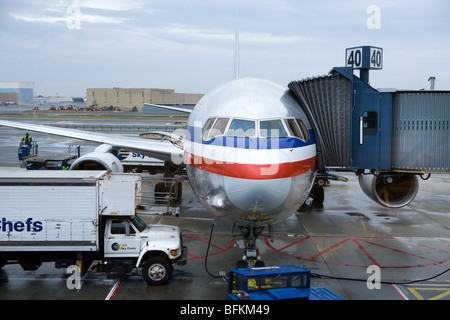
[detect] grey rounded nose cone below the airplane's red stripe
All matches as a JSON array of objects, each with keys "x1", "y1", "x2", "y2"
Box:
[{"x1": 224, "y1": 177, "x2": 292, "y2": 212}]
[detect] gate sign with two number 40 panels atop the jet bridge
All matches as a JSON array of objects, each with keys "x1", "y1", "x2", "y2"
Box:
[{"x1": 345, "y1": 46, "x2": 383, "y2": 69}]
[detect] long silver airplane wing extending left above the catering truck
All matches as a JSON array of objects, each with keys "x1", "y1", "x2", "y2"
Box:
[{"x1": 0, "y1": 120, "x2": 183, "y2": 164}]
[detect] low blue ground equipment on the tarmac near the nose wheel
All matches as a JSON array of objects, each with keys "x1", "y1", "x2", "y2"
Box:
[{"x1": 227, "y1": 265, "x2": 342, "y2": 300}]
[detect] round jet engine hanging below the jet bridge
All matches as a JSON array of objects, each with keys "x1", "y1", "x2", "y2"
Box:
[{"x1": 358, "y1": 173, "x2": 419, "y2": 208}]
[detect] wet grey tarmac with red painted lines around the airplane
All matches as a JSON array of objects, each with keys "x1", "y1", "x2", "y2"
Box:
[{"x1": 0, "y1": 115, "x2": 450, "y2": 301}]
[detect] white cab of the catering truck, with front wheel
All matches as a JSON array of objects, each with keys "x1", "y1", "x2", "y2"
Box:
[{"x1": 101, "y1": 216, "x2": 187, "y2": 285}]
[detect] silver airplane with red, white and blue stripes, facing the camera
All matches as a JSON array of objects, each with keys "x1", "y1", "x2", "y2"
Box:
[{"x1": 0, "y1": 78, "x2": 316, "y2": 266}]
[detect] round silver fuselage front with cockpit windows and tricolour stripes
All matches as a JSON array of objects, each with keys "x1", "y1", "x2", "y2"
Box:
[{"x1": 184, "y1": 78, "x2": 316, "y2": 227}]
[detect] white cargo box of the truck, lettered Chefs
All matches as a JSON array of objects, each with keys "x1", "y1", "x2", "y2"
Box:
[{"x1": 0, "y1": 170, "x2": 141, "y2": 251}]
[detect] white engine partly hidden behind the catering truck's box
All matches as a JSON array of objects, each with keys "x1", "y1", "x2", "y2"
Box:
[{"x1": 70, "y1": 144, "x2": 124, "y2": 172}]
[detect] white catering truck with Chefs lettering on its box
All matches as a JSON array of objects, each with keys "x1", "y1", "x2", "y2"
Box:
[{"x1": 0, "y1": 170, "x2": 187, "y2": 285}]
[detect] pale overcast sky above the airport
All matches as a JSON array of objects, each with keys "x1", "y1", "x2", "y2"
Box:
[{"x1": 0, "y1": 0, "x2": 450, "y2": 97}]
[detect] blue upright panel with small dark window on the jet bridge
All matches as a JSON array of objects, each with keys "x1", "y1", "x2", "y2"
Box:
[{"x1": 352, "y1": 92, "x2": 380, "y2": 169}]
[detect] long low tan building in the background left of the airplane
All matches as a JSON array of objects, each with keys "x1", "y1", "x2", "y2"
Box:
[{"x1": 86, "y1": 88, "x2": 203, "y2": 112}]
